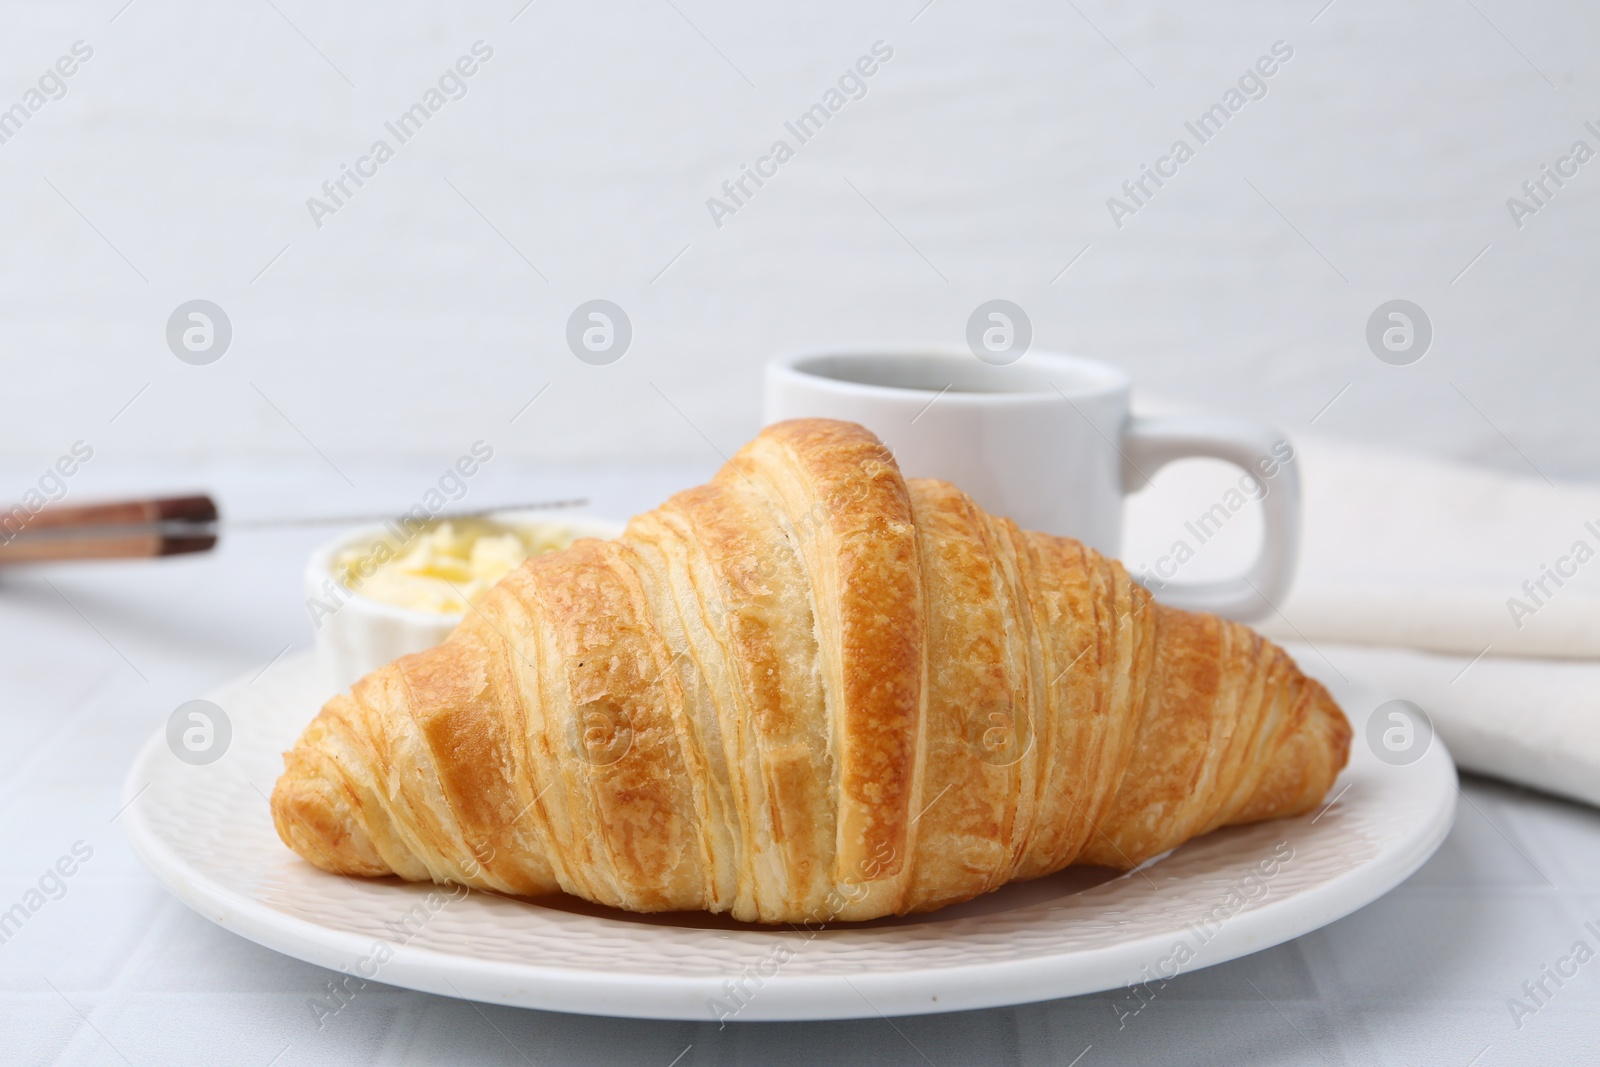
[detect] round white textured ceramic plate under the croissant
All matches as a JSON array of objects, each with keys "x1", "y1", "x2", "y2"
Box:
[{"x1": 122, "y1": 654, "x2": 1456, "y2": 1021}]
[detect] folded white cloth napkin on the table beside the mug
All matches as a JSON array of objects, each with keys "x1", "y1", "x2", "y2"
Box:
[{"x1": 1125, "y1": 437, "x2": 1600, "y2": 805}]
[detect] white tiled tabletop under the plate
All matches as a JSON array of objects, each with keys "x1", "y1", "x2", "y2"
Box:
[{"x1": 0, "y1": 469, "x2": 1600, "y2": 1067}]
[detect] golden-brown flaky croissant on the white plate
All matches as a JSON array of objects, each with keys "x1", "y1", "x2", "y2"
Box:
[{"x1": 272, "y1": 419, "x2": 1350, "y2": 923}]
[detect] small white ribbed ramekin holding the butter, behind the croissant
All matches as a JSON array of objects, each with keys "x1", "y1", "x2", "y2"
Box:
[{"x1": 304, "y1": 512, "x2": 626, "y2": 689}]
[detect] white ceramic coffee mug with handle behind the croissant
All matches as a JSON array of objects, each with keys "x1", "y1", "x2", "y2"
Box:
[{"x1": 766, "y1": 347, "x2": 1301, "y2": 621}]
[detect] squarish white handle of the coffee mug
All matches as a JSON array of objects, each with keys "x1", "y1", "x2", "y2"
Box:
[{"x1": 1122, "y1": 414, "x2": 1301, "y2": 622}]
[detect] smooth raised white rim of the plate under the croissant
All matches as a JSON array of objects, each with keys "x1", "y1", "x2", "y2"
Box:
[{"x1": 122, "y1": 651, "x2": 1459, "y2": 1022}]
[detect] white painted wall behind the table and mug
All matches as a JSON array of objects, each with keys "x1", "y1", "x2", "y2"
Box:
[{"x1": 0, "y1": 0, "x2": 1600, "y2": 490}]
